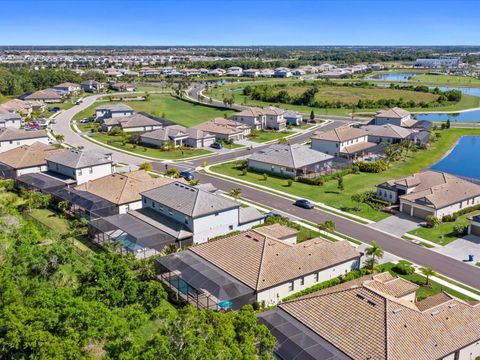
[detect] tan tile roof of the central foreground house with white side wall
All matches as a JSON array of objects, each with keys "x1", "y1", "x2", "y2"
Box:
[{"x1": 190, "y1": 230, "x2": 360, "y2": 290}]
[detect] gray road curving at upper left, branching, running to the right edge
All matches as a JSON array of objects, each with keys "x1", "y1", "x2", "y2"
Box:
[{"x1": 52, "y1": 95, "x2": 480, "y2": 289}]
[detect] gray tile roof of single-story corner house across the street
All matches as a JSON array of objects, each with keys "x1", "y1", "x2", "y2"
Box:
[{"x1": 248, "y1": 144, "x2": 333, "y2": 169}]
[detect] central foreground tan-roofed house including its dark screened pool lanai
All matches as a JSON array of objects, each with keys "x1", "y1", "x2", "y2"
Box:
[{"x1": 157, "y1": 226, "x2": 362, "y2": 310}]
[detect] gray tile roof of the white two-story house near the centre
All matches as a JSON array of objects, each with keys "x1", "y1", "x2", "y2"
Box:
[{"x1": 142, "y1": 182, "x2": 240, "y2": 218}]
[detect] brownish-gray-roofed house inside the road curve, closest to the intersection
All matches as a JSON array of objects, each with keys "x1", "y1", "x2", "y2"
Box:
[{"x1": 140, "y1": 125, "x2": 215, "y2": 149}]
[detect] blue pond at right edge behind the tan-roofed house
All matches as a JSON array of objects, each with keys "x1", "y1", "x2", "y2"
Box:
[{"x1": 430, "y1": 136, "x2": 480, "y2": 180}]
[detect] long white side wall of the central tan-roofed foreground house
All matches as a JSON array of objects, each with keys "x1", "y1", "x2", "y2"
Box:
[{"x1": 257, "y1": 258, "x2": 360, "y2": 306}]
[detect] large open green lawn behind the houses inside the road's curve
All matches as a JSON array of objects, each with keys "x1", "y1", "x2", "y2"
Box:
[{"x1": 73, "y1": 94, "x2": 234, "y2": 127}]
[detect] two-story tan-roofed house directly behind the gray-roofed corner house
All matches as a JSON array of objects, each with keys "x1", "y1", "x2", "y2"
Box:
[{"x1": 311, "y1": 126, "x2": 376, "y2": 158}]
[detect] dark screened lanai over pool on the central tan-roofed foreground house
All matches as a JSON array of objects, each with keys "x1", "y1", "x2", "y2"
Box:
[{"x1": 156, "y1": 250, "x2": 255, "y2": 310}]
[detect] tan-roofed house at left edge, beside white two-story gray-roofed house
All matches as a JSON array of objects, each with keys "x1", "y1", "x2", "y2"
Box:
[{"x1": 0, "y1": 142, "x2": 66, "y2": 179}]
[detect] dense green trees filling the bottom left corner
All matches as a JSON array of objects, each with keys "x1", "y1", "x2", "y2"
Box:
[{"x1": 0, "y1": 195, "x2": 275, "y2": 360}]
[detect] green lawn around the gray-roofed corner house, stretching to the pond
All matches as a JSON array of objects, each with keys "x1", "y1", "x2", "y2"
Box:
[{"x1": 211, "y1": 128, "x2": 480, "y2": 221}]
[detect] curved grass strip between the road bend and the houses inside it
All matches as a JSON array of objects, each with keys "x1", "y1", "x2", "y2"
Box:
[{"x1": 90, "y1": 133, "x2": 211, "y2": 160}]
